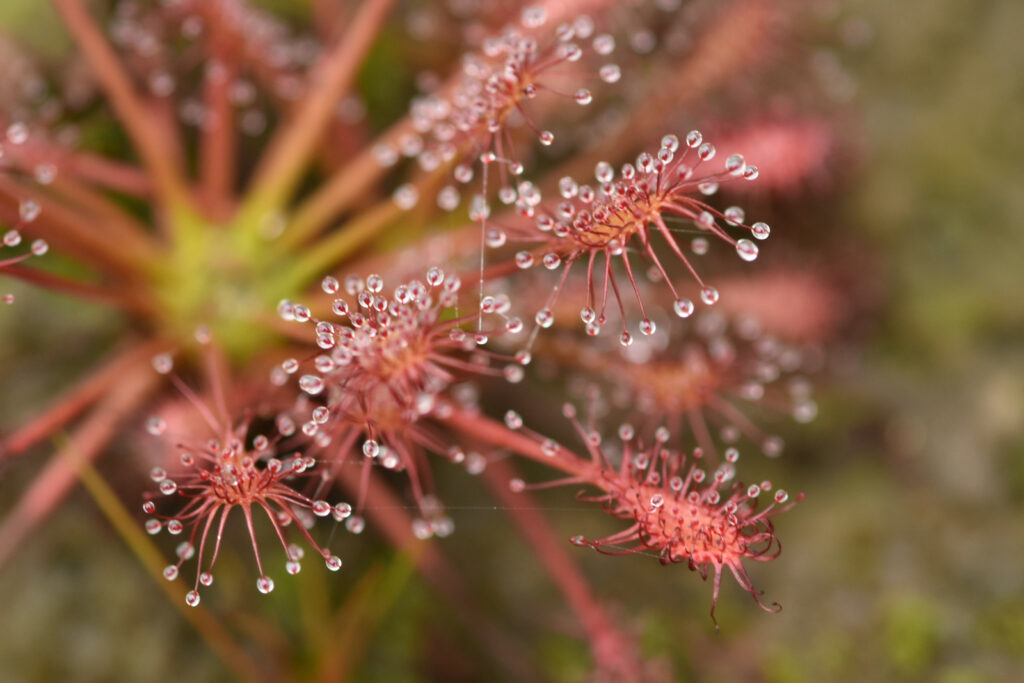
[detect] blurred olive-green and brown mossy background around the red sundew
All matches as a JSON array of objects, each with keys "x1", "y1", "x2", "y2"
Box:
[{"x1": 0, "y1": 0, "x2": 1024, "y2": 683}]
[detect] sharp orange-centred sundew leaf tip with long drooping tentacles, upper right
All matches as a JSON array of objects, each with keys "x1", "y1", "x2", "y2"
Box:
[{"x1": 516, "y1": 131, "x2": 770, "y2": 339}]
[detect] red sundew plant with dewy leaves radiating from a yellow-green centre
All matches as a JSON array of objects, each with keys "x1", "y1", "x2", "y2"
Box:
[{"x1": 0, "y1": 0, "x2": 848, "y2": 681}]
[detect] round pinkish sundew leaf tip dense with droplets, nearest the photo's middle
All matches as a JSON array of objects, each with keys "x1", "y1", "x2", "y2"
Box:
[{"x1": 279, "y1": 267, "x2": 529, "y2": 518}]
